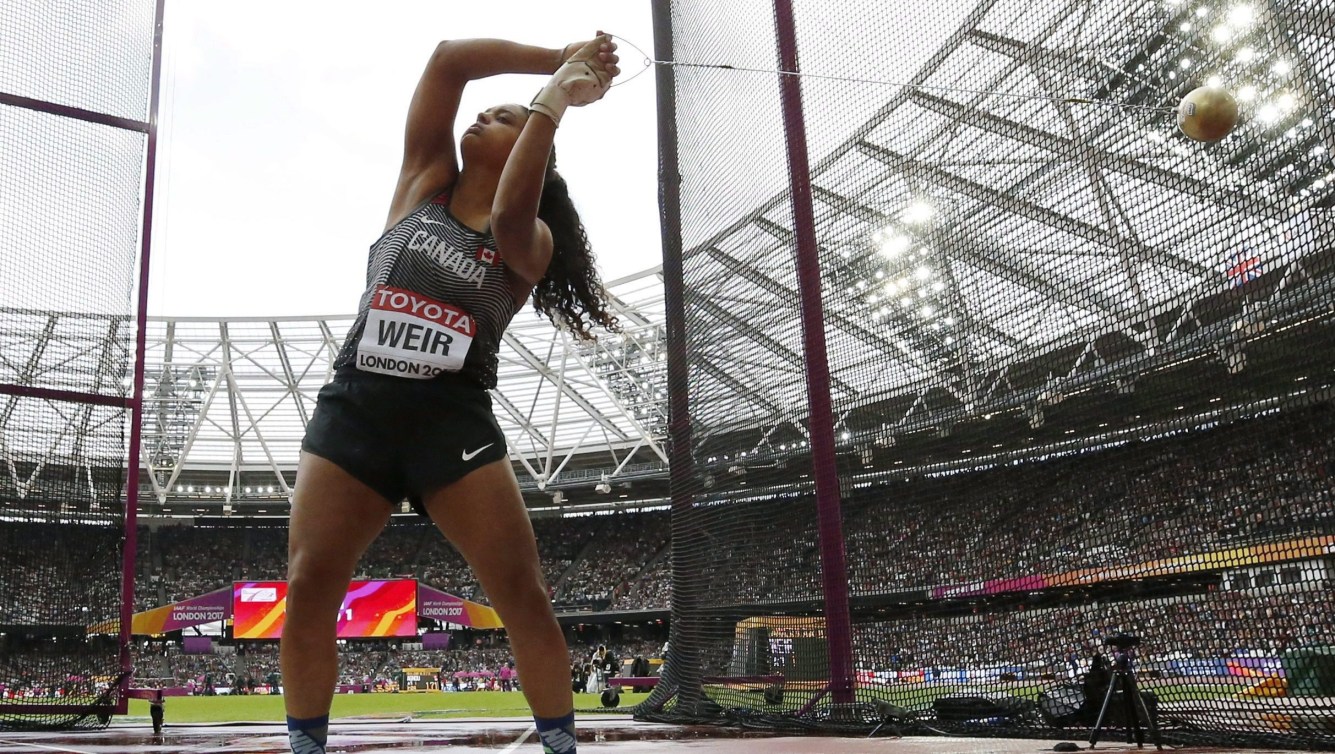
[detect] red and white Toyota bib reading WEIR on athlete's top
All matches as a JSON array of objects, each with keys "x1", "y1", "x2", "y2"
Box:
[{"x1": 355, "y1": 286, "x2": 477, "y2": 379}]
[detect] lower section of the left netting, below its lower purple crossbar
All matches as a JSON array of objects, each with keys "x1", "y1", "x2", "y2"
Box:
[{"x1": 0, "y1": 395, "x2": 128, "y2": 729}]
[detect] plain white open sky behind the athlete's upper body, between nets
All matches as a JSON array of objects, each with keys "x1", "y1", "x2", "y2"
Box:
[{"x1": 150, "y1": 0, "x2": 661, "y2": 316}]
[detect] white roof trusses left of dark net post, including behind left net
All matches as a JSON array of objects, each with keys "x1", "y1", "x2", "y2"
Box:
[{"x1": 0, "y1": 270, "x2": 666, "y2": 510}]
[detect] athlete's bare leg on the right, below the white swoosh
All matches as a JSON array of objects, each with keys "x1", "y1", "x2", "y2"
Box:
[{"x1": 423, "y1": 458, "x2": 574, "y2": 718}]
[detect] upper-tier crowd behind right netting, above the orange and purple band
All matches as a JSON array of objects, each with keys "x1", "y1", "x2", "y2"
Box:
[{"x1": 848, "y1": 404, "x2": 1335, "y2": 593}]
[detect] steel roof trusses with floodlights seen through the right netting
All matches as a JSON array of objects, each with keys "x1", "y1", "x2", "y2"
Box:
[{"x1": 677, "y1": 0, "x2": 1335, "y2": 450}]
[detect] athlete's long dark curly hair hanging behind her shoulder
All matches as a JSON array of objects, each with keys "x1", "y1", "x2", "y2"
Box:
[{"x1": 533, "y1": 149, "x2": 621, "y2": 340}]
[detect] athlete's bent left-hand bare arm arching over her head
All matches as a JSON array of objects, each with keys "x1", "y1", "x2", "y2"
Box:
[{"x1": 386, "y1": 39, "x2": 578, "y2": 227}]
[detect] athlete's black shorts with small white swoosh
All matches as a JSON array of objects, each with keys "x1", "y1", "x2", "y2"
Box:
[{"x1": 298, "y1": 368, "x2": 507, "y2": 515}]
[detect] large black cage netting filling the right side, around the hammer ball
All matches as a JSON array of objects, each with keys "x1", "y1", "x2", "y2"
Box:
[{"x1": 639, "y1": 0, "x2": 1335, "y2": 749}]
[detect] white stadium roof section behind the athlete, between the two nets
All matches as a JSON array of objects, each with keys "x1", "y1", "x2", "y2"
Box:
[{"x1": 144, "y1": 264, "x2": 666, "y2": 496}]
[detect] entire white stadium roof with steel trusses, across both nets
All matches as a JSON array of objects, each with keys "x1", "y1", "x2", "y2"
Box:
[{"x1": 0, "y1": 0, "x2": 1335, "y2": 512}]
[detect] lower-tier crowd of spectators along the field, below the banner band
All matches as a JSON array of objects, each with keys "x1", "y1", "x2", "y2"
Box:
[{"x1": 10, "y1": 581, "x2": 1335, "y2": 695}]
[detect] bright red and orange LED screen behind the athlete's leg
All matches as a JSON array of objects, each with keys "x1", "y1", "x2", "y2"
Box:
[{"x1": 232, "y1": 579, "x2": 417, "y2": 639}]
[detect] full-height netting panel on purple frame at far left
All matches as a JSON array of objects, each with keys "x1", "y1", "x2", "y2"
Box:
[{"x1": 0, "y1": 0, "x2": 155, "y2": 730}]
